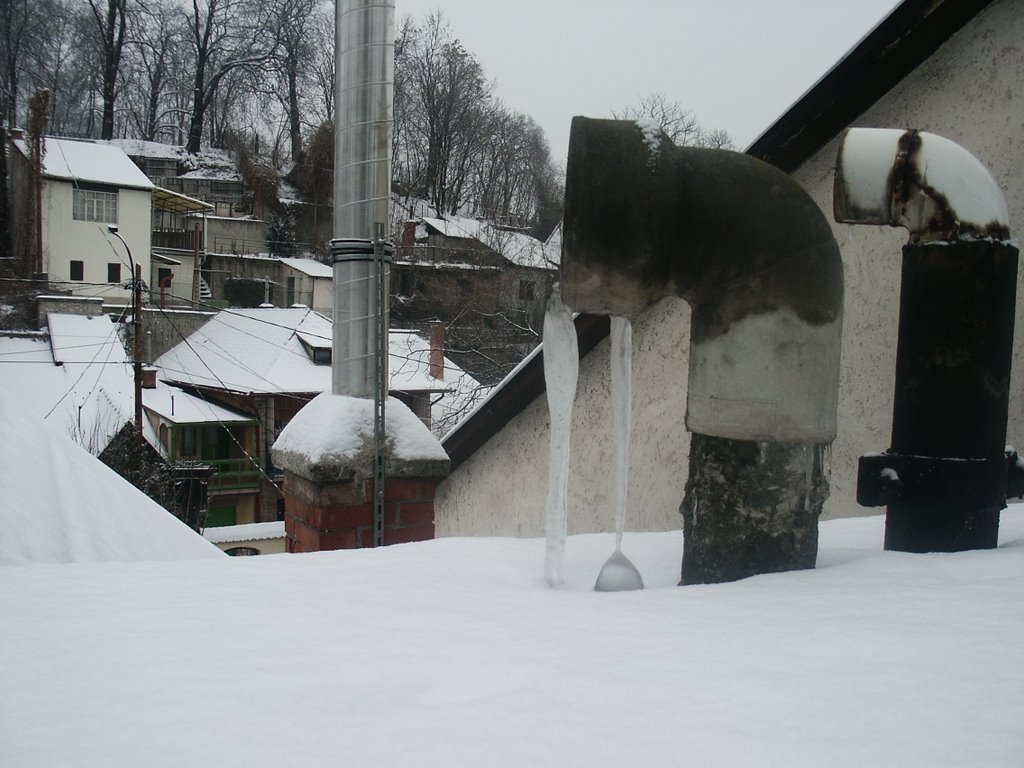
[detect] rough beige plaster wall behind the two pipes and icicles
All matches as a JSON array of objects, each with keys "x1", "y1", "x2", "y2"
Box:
[{"x1": 435, "y1": 0, "x2": 1024, "y2": 537}]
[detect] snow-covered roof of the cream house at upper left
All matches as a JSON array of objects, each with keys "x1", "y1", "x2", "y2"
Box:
[{"x1": 14, "y1": 138, "x2": 154, "y2": 189}]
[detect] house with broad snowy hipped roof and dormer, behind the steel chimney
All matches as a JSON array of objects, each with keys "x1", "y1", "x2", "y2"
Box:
[{"x1": 154, "y1": 306, "x2": 485, "y2": 523}]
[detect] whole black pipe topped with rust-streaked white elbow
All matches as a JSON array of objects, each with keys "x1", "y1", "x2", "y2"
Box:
[{"x1": 835, "y1": 128, "x2": 1021, "y2": 552}]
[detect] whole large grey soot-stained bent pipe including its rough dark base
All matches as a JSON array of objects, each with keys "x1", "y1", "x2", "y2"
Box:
[{"x1": 561, "y1": 118, "x2": 843, "y2": 584}]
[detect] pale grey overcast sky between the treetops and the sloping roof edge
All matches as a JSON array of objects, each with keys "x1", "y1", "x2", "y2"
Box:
[{"x1": 395, "y1": 0, "x2": 896, "y2": 165}]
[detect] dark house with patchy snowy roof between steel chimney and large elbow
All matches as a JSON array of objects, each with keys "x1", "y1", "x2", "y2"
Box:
[{"x1": 391, "y1": 216, "x2": 561, "y2": 383}]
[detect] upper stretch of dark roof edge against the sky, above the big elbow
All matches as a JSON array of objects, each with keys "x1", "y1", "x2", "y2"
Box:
[{"x1": 746, "y1": 0, "x2": 991, "y2": 173}]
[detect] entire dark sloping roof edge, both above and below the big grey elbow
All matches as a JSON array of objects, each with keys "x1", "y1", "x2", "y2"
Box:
[{"x1": 441, "y1": 0, "x2": 991, "y2": 471}]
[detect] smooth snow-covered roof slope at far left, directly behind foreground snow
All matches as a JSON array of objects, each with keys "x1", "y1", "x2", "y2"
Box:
[{"x1": 0, "y1": 397, "x2": 221, "y2": 565}]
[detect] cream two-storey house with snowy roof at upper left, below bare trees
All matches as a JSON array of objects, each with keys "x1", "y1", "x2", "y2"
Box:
[{"x1": 10, "y1": 137, "x2": 212, "y2": 313}]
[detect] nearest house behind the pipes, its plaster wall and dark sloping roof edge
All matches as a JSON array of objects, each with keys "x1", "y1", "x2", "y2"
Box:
[{"x1": 435, "y1": 0, "x2": 1024, "y2": 536}]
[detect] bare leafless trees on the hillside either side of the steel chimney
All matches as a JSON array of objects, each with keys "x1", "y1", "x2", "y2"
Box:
[{"x1": 0, "y1": 0, "x2": 562, "y2": 239}]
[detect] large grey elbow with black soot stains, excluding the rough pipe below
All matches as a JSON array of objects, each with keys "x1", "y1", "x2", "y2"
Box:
[{"x1": 561, "y1": 118, "x2": 843, "y2": 442}]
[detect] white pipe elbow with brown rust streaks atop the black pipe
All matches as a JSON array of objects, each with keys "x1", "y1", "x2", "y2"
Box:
[{"x1": 833, "y1": 128, "x2": 1010, "y2": 243}]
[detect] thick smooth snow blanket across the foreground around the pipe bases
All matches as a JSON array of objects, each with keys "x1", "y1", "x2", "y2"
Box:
[{"x1": 0, "y1": 507, "x2": 1024, "y2": 768}]
